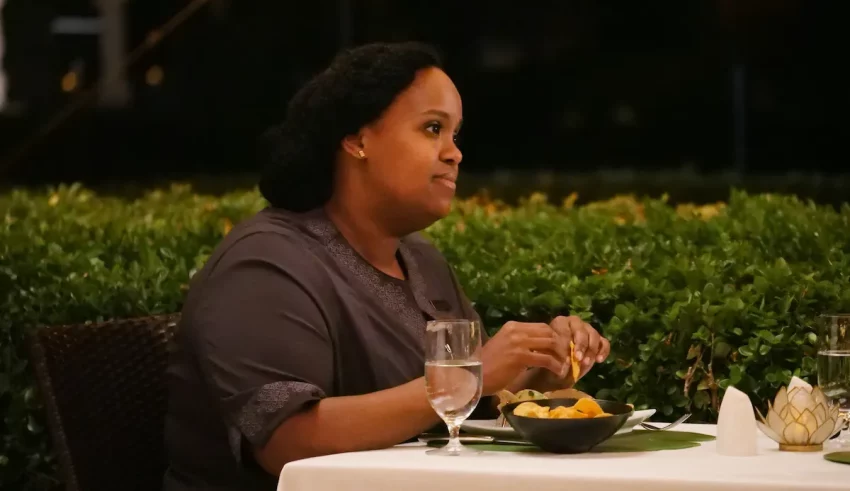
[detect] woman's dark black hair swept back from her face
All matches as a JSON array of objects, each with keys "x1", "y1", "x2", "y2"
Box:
[{"x1": 260, "y1": 42, "x2": 442, "y2": 212}]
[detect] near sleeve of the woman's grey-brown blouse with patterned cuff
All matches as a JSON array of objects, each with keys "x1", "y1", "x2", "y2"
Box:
[{"x1": 184, "y1": 232, "x2": 334, "y2": 461}]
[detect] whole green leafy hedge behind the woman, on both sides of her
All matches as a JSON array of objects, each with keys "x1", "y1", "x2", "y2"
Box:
[{"x1": 0, "y1": 187, "x2": 850, "y2": 489}]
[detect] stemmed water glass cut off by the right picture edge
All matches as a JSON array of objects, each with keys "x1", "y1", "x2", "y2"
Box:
[{"x1": 818, "y1": 314, "x2": 850, "y2": 447}]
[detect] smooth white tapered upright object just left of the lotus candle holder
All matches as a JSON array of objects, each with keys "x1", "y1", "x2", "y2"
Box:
[{"x1": 717, "y1": 386, "x2": 757, "y2": 457}]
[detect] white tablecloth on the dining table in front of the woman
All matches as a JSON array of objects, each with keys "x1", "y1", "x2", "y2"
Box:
[{"x1": 278, "y1": 424, "x2": 850, "y2": 491}]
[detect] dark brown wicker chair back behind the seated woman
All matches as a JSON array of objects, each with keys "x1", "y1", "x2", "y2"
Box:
[{"x1": 31, "y1": 314, "x2": 179, "y2": 491}]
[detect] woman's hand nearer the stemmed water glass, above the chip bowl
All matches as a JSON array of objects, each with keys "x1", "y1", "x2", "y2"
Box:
[{"x1": 481, "y1": 321, "x2": 570, "y2": 396}]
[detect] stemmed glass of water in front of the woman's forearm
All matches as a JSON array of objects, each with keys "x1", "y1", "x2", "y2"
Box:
[{"x1": 425, "y1": 319, "x2": 483, "y2": 455}]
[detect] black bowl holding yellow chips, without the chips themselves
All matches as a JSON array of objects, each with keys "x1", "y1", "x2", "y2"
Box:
[{"x1": 502, "y1": 399, "x2": 634, "y2": 453}]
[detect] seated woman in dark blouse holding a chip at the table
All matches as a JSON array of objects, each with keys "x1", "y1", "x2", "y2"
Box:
[{"x1": 166, "y1": 43, "x2": 609, "y2": 490}]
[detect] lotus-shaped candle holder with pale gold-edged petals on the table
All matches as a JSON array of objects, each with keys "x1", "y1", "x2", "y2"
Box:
[{"x1": 756, "y1": 377, "x2": 844, "y2": 452}]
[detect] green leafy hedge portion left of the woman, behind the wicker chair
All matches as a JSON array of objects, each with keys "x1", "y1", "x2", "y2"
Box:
[{"x1": 0, "y1": 187, "x2": 264, "y2": 489}]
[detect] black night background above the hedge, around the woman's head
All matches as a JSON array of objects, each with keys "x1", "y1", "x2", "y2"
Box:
[{"x1": 0, "y1": 0, "x2": 850, "y2": 195}]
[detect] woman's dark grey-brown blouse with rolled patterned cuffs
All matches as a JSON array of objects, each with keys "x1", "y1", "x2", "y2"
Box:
[{"x1": 165, "y1": 208, "x2": 486, "y2": 491}]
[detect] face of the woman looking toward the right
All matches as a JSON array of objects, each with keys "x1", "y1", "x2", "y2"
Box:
[{"x1": 348, "y1": 68, "x2": 463, "y2": 230}]
